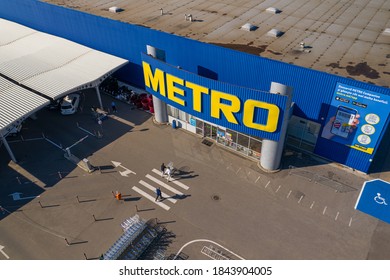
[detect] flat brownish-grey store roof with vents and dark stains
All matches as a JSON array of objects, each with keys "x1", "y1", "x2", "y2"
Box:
[{"x1": 44, "y1": 0, "x2": 390, "y2": 87}]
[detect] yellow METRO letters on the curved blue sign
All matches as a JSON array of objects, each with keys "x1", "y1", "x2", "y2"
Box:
[{"x1": 142, "y1": 61, "x2": 280, "y2": 133}]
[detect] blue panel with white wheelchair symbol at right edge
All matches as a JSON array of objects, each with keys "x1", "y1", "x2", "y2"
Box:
[{"x1": 355, "y1": 179, "x2": 390, "y2": 223}]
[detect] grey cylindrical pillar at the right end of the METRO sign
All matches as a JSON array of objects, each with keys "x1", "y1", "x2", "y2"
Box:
[{"x1": 260, "y1": 82, "x2": 292, "y2": 171}]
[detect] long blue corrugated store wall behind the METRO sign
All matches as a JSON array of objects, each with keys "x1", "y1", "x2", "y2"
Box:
[{"x1": 0, "y1": 0, "x2": 390, "y2": 173}]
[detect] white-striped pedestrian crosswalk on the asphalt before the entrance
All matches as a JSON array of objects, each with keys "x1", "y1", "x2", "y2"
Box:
[{"x1": 132, "y1": 169, "x2": 190, "y2": 211}]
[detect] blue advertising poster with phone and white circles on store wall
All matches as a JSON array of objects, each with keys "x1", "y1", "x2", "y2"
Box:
[{"x1": 321, "y1": 83, "x2": 390, "y2": 154}]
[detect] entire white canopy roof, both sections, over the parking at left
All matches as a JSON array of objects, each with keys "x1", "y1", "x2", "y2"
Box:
[{"x1": 0, "y1": 18, "x2": 128, "y2": 136}]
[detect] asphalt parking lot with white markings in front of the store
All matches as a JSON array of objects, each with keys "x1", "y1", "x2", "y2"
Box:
[{"x1": 0, "y1": 88, "x2": 390, "y2": 260}]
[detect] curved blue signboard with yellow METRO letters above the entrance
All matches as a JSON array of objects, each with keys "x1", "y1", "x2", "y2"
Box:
[{"x1": 142, "y1": 54, "x2": 288, "y2": 141}]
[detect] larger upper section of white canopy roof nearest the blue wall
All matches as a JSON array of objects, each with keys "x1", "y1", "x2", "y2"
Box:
[{"x1": 0, "y1": 19, "x2": 128, "y2": 99}]
